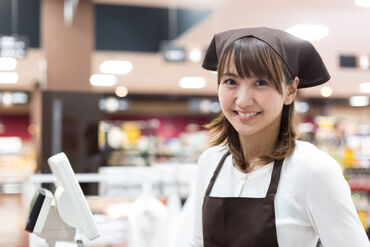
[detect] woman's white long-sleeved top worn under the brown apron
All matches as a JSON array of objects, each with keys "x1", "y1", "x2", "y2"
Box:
[{"x1": 191, "y1": 141, "x2": 370, "y2": 247}]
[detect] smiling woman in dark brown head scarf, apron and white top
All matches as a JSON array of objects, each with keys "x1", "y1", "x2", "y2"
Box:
[{"x1": 192, "y1": 28, "x2": 369, "y2": 247}]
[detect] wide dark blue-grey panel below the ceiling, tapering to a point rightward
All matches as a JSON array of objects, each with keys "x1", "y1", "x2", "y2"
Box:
[{"x1": 95, "y1": 4, "x2": 211, "y2": 52}]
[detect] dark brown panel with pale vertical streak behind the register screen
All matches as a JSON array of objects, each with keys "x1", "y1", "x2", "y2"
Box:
[{"x1": 41, "y1": 91, "x2": 105, "y2": 173}]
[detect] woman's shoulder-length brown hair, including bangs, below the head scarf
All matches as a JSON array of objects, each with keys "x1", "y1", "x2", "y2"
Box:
[{"x1": 206, "y1": 37, "x2": 296, "y2": 170}]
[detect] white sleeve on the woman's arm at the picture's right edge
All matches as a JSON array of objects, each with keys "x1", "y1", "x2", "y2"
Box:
[{"x1": 306, "y1": 153, "x2": 370, "y2": 247}]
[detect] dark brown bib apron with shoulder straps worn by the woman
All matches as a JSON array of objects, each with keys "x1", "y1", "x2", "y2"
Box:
[{"x1": 203, "y1": 153, "x2": 283, "y2": 247}]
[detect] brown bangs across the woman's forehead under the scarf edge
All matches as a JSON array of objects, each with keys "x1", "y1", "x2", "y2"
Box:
[{"x1": 217, "y1": 37, "x2": 291, "y2": 93}]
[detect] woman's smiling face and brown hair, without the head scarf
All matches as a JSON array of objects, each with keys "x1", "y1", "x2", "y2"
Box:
[{"x1": 209, "y1": 37, "x2": 298, "y2": 170}]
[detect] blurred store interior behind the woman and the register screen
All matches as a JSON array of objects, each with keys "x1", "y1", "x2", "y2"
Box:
[{"x1": 0, "y1": 0, "x2": 370, "y2": 246}]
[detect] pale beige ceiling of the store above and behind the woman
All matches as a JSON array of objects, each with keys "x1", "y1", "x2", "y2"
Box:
[{"x1": 0, "y1": 0, "x2": 370, "y2": 98}]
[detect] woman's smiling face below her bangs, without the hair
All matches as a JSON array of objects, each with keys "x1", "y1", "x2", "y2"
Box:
[{"x1": 218, "y1": 63, "x2": 294, "y2": 137}]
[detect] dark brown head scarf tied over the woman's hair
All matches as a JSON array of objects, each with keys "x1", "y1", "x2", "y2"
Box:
[{"x1": 202, "y1": 27, "x2": 330, "y2": 88}]
